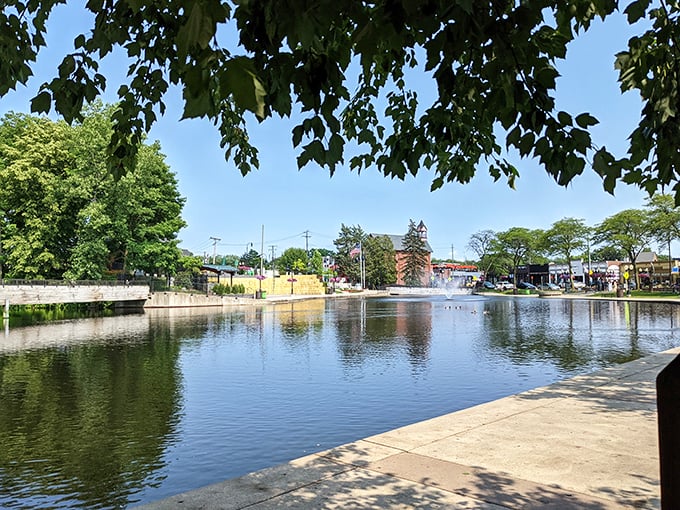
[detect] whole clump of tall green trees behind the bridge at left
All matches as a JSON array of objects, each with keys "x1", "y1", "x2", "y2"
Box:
[{"x1": 0, "y1": 104, "x2": 185, "y2": 279}]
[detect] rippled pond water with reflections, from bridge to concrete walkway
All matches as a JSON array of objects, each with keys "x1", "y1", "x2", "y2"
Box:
[{"x1": 0, "y1": 296, "x2": 680, "y2": 508}]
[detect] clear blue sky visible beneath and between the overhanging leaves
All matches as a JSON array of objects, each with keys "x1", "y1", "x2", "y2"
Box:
[{"x1": 0, "y1": 3, "x2": 646, "y2": 260}]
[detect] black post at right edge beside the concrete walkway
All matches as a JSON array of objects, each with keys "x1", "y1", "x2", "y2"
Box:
[{"x1": 656, "y1": 355, "x2": 680, "y2": 510}]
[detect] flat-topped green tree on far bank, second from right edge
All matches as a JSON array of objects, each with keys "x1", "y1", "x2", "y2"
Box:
[{"x1": 595, "y1": 209, "x2": 653, "y2": 289}]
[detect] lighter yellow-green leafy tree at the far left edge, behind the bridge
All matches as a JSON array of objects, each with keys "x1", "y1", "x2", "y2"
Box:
[{"x1": 0, "y1": 115, "x2": 83, "y2": 278}]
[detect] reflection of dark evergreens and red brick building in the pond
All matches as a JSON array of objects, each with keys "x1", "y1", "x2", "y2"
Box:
[{"x1": 335, "y1": 299, "x2": 432, "y2": 368}]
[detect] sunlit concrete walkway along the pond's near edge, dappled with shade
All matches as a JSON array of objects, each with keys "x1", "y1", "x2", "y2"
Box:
[{"x1": 137, "y1": 349, "x2": 680, "y2": 510}]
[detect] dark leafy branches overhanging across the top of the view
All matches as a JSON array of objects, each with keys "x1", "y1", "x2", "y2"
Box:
[{"x1": 0, "y1": 0, "x2": 680, "y2": 197}]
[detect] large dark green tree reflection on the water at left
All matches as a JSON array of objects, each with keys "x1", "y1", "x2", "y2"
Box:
[{"x1": 0, "y1": 320, "x2": 181, "y2": 508}]
